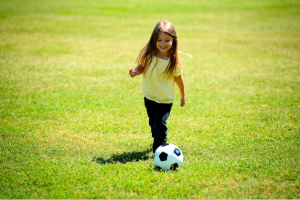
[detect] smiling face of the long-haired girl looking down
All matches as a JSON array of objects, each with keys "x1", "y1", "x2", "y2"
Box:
[{"x1": 156, "y1": 32, "x2": 173, "y2": 56}]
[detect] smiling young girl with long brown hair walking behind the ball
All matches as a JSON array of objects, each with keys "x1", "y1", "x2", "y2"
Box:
[{"x1": 129, "y1": 21, "x2": 185, "y2": 153}]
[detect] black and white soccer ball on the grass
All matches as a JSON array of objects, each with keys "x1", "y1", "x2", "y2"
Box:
[{"x1": 154, "y1": 144, "x2": 183, "y2": 171}]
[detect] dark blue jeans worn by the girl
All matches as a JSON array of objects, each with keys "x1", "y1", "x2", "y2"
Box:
[{"x1": 144, "y1": 97, "x2": 173, "y2": 152}]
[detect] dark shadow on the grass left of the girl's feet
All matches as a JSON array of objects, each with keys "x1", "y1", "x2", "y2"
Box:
[{"x1": 93, "y1": 149, "x2": 152, "y2": 164}]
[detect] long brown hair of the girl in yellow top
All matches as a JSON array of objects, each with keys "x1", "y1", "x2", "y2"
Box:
[{"x1": 136, "y1": 21, "x2": 182, "y2": 77}]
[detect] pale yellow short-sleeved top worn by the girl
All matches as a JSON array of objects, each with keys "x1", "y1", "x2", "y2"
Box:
[{"x1": 142, "y1": 57, "x2": 182, "y2": 103}]
